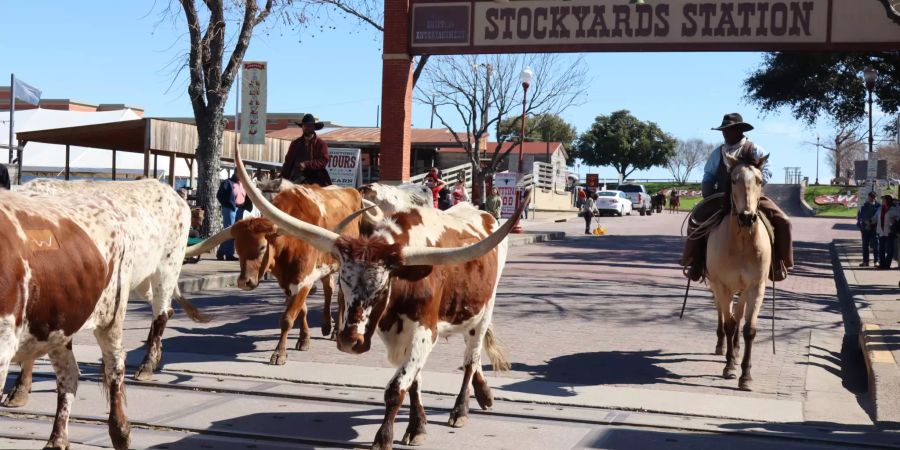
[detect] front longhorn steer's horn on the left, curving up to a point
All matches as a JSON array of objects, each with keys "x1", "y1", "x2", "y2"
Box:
[{"x1": 234, "y1": 146, "x2": 340, "y2": 253}]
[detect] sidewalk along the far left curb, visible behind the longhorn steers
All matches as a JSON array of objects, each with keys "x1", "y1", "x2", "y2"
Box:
[{"x1": 178, "y1": 229, "x2": 566, "y2": 294}]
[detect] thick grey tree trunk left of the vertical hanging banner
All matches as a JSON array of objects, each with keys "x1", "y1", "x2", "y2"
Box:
[{"x1": 197, "y1": 108, "x2": 225, "y2": 236}]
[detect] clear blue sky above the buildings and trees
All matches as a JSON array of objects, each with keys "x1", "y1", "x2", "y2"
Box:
[{"x1": 0, "y1": 0, "x2": 877, "y2": 182}]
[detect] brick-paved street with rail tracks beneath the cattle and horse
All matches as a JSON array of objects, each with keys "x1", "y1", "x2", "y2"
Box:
[{"x1": 0, "y1": 214, "x2": 900, "y2": 448}]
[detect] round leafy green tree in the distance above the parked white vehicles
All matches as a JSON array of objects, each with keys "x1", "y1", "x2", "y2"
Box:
[{"x1": 576, "y1": 109, "x2": 677, "y2": 179}]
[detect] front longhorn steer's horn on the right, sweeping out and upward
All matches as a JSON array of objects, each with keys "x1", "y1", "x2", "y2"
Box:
[{"x1": 403, "y1": 189, "x2": 531, "y2": 266}]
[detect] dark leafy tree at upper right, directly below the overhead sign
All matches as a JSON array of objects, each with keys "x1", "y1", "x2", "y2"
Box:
[{"x1": 744, "y1": 52, "x2": 900, "y2": 127}]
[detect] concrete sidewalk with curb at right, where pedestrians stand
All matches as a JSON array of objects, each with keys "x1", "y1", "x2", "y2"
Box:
[{"x1": 833, "y1": 239, "x2": 900, "y2": 427}]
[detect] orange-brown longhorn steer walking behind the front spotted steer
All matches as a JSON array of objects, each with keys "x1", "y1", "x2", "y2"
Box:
[{"x1": 206, "y1": 181, "x2": 361, "y2": 365}]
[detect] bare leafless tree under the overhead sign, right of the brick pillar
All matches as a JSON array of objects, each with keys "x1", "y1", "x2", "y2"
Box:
[{"x1": 416, "y1": 54, "x2": 587, "y2": 204}]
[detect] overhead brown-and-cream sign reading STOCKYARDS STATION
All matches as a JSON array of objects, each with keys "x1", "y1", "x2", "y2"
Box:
[{"x1": 410, "y1": 0, "x2": 900, "y2": 54}]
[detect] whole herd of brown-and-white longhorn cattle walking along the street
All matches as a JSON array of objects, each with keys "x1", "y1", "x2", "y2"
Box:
[{"x1": 0, "y1": 149, "x2": 527, "y2": 449}]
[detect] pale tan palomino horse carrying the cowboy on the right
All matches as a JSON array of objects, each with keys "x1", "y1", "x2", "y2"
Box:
[{"x1": 706, "y1": 151, "x2": 774, "y2": 391}]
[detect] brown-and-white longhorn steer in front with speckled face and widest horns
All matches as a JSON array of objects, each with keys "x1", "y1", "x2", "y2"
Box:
[{"x1": 235, "y1": 153, "x2": 528, "y2": 448}]
